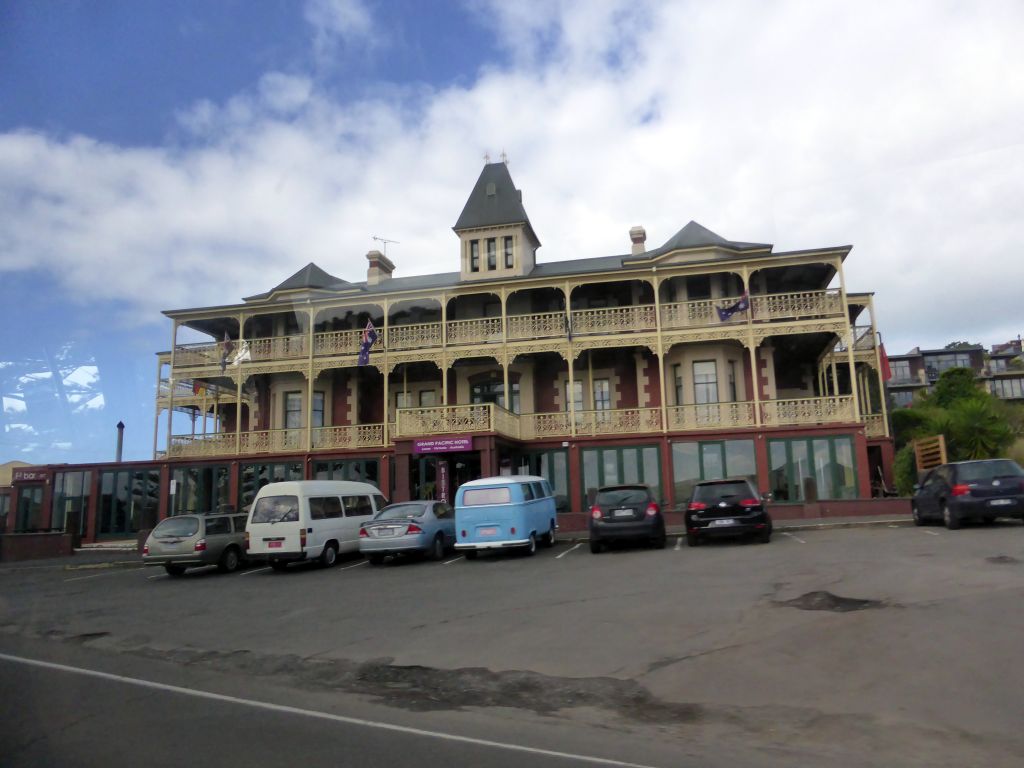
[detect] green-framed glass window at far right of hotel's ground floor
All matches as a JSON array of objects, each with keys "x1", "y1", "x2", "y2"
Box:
[{"x1": 768, "y1": 435, "x2": 857, "y2": 502}]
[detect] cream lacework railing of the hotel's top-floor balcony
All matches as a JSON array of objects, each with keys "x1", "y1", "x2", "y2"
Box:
[{"x1": 165, "y1": 290, "x2": 839, "y2": 369}]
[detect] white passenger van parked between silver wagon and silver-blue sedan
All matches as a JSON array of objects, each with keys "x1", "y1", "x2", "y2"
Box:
[{"x1": 246, "y1": 480, "x2": 387, "y2": 570}]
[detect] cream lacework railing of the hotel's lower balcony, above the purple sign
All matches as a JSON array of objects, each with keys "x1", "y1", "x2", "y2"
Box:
[{"x1": 167, "y1": 395, "x2": 885, "y2": 458}]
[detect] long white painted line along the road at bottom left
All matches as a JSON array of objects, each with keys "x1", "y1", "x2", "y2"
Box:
[{"x1": 0, "y1": 653, "x2": 651, "y2": 768}]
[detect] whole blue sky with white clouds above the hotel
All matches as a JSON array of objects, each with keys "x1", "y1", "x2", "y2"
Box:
[{"x1": 0, "y1": 0, "x2": 1024, "y2": 463}]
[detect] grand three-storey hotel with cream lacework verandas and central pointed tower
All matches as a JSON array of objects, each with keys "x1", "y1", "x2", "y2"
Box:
[{"x1": 7, "y1": 163, "x2": 892, "y2": 541}]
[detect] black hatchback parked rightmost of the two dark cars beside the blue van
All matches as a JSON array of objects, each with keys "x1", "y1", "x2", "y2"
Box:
[{"x1": 686, "y1": 477, "x2": 771, "y2": 547}]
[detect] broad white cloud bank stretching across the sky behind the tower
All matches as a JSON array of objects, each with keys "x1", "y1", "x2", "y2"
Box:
[{"x1": 0, "y1": 0, "x2": 1024, "y2": 352}]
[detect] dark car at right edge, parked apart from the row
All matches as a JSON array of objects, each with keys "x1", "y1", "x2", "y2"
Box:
[{"x1": 910, "y1": 459, "x2": 1024, "y2": 530}]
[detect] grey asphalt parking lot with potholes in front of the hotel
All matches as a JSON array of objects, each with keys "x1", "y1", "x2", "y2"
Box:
[{"x1": 0, "y1": 522, "x2": 1024, "y2": 766}]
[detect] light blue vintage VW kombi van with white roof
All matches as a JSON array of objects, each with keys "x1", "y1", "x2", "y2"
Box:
[{"x1": 455, "y1": 475, "x2": 558, "y2": 560}]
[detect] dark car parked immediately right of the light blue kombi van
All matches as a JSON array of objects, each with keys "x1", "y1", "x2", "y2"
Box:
[{"x1": 590, "y1": 485, "x2": 665, "y2": 555}]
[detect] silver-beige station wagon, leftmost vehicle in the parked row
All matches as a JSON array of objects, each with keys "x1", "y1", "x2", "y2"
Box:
[{"x1": 142, "y1": 513, "x2": 246, "y2": 577}]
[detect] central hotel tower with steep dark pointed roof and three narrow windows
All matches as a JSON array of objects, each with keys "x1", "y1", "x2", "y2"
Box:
[{"x1": 452, "y1": 162, "x2": 541, "y2": 281}]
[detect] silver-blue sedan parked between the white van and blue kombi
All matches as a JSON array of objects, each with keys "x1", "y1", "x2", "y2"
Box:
[{"x1": 359, "y1": 500, "x2": 455, "y2": 565}]
